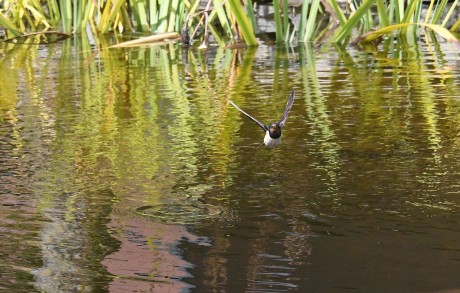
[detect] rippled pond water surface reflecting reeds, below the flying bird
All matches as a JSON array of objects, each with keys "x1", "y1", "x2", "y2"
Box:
[{"x1": 0, "y1": 37, "x2": 460, "y2": 292}]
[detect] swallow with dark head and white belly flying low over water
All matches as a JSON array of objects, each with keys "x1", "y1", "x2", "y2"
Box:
[{"x1": 229, "y1": 90, "x2": 295, "y2": 148}]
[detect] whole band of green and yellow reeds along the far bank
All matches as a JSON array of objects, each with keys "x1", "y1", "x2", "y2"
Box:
[{"x1": 0, "y1": 0, "x2": 460, "y2": 46}]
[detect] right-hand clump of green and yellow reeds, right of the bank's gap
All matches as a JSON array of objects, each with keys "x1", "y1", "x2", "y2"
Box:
[{"x1": 273, "y1": 0, "x2": 460, "y2": 43}]
